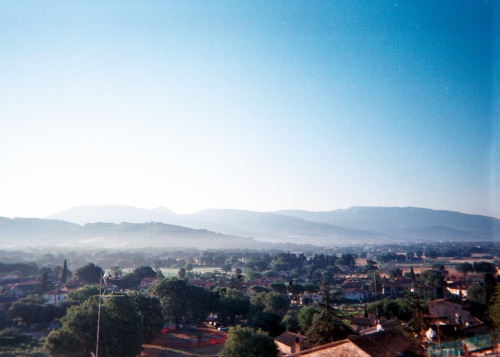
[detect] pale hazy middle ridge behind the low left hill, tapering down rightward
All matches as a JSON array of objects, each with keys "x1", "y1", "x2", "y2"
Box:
[{"x1": 49, "y1": 206, "x2": 383, "y2": 246}]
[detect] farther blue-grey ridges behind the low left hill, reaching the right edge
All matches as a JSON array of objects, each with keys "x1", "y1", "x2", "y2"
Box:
[{"x1": 49, "y1": 206, "x2": 500, "y2": 246}]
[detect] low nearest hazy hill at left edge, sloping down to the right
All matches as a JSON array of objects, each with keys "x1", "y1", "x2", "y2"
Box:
[{"x1": 0, "y1": 217, "x2": 279, "y2": 249}]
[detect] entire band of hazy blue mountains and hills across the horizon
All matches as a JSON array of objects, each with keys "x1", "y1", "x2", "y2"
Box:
[{"x1": 0, "y1": 206, "x2": 500, "y2": 249}]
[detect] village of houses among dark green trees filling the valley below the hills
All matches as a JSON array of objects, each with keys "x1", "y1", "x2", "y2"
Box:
[{"x1": 0, "y1": 242, "x2": 500, "y2": 356}]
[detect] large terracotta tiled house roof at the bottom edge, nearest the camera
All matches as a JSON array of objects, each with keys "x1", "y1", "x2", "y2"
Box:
[{"x1": 287, "y1": 329, "x2": 425, "y2": 357}]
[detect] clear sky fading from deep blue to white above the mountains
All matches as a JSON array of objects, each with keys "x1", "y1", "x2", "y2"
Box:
[{"x1": 0, "y1": 0, "x2": 500, "y2": 217}]
